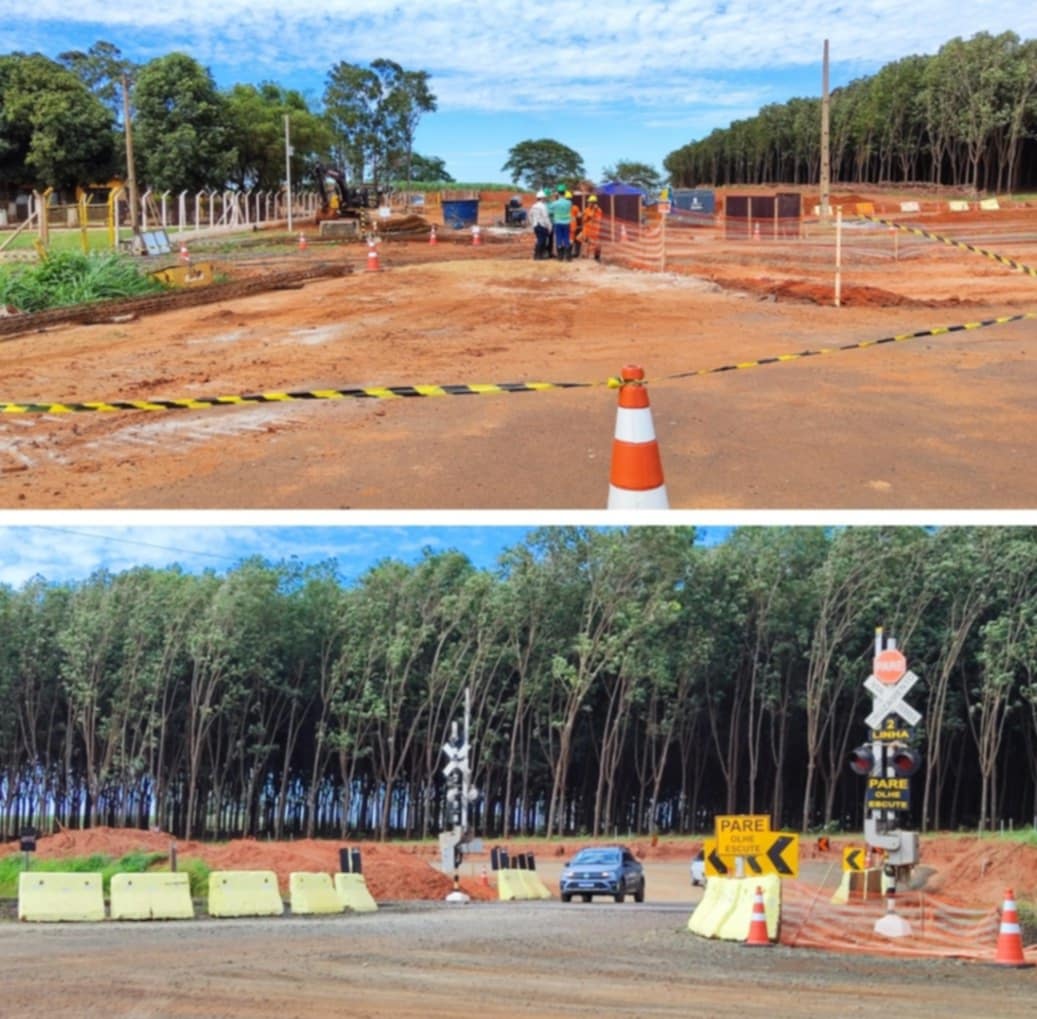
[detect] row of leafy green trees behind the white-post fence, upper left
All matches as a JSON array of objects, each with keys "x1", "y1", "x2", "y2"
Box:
[{"x1": 0, "y1": 41, "x2": 441, "y2": 199}]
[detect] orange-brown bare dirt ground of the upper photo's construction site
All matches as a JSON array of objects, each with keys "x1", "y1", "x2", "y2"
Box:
[{"x1": 0, "y1": 188, "x2": 1037, "y2": 510}]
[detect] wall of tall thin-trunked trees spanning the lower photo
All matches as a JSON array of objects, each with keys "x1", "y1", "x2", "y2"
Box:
[{"x1": 0, "y1": 527, "x2": 1037, "y2": 839}]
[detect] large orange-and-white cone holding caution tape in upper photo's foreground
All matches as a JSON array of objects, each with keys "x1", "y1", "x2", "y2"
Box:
[{"x1": 608, "y1": 365, "x2": 670, "y2": 509}]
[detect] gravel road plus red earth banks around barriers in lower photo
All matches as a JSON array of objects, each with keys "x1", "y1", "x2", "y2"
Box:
[{"x1": 0, "y1": 828, "x2": 1037, "y2": 1019}]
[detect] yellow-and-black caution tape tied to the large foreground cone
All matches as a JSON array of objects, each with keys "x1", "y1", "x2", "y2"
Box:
[{"x1": 0, "y1": 311, "x2": 1037, "y2": 414}]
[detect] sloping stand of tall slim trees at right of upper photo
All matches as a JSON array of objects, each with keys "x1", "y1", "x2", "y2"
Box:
[{"x1": 663, "y1": 32, "x2": 1037, "y2": 193}]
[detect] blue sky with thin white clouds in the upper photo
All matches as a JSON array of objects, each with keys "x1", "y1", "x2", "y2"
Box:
[{"x1": 10, "y1": 0, "x2": 1037, "y2": 182}]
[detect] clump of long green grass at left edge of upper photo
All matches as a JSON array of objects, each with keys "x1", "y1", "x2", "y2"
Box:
[{"x1": 0, "y1": 251, "x2": 166, "y2": 312}]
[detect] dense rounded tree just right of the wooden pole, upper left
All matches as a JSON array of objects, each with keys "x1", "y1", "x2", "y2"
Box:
[{"x1": 134, "y1": 53, "x2": 236, "y2": 192}]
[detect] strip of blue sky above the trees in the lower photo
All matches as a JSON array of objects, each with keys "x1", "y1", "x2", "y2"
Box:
[{"x1": 0, "y1": 522, "x2": 728, "y2": 589}]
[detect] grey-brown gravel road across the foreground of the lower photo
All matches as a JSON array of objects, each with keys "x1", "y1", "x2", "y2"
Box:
[{"x1": 0, "y1": 901, "x2": 1037, "y2": 1019}]
